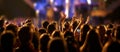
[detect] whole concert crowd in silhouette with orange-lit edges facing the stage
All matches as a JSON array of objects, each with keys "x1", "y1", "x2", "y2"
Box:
[{"x1": 0, "y1": 13, "x2": 120, "y2": 52}]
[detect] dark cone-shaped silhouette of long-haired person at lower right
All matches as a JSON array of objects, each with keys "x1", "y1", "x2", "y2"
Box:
[{"x1": 80, "y1": 29, "x2": 103, "y2": 52}]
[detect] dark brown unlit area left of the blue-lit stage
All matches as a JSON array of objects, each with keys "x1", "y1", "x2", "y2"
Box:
[{"x1": 0, "y1": 0, "x2": 35, "y2": 19}]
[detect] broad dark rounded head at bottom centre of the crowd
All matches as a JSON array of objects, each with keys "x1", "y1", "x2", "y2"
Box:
[{"x1": 47, "y1": 38, "x2": 68, "y2": 52}]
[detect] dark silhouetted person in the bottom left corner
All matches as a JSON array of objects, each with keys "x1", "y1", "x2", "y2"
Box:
[{"x1": 1, "y1": 31, "x2": 16, "y2": 52}]
